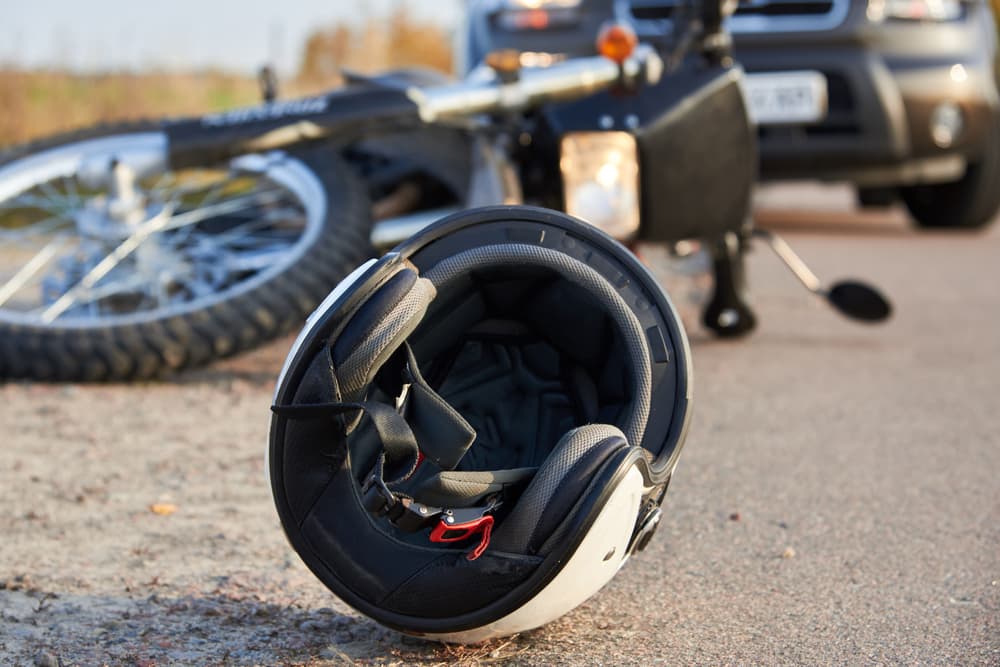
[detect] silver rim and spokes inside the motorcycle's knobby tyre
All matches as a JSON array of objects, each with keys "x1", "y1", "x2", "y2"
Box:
[{"x1": 0, "y1": 132, "x2": 328, "y2": 328}]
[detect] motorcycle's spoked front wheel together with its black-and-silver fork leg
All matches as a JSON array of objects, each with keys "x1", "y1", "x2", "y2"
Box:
[{"x1": 0, "y1": 30, "x2": 662, "y2": 380}]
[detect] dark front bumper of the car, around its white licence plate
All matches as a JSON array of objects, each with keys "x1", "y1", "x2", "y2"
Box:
[{"x1": 736, "y1": 25, "x2": 998, "y2": 185}]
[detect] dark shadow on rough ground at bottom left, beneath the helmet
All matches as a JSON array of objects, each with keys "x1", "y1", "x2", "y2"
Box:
[{"x1": 0, "y1": 585, "x2": 527, "y2": 667}]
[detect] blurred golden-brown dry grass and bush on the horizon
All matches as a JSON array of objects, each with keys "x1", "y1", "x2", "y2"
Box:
[{"x1": 0, "y1": 6, "x2": 451, "y2": 146}]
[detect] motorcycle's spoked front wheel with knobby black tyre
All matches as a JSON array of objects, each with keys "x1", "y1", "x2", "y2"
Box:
[{"x1": 0, "y1": 125, "x2": 373, "y2": 381}]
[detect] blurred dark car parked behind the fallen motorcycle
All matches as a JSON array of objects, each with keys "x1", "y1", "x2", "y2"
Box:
[{"x1": 472, "y1": 0, "x2": 1000, "y2": 228}]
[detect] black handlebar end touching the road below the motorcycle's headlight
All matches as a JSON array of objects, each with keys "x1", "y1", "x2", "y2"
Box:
[{"x1": 702, "y1": 232, "x2": 757, "y2": 338}]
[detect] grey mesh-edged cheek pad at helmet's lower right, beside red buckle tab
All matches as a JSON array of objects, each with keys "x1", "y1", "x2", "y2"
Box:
[{"x1": 492, "y1": 424, "x2": 628, "y2": 554}]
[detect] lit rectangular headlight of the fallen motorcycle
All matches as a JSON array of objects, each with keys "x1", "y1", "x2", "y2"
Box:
[{"x1": 559, "y1": 132, "x2": 639, "y2": 241}]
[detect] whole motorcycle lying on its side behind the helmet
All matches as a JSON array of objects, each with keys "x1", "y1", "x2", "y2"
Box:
[{"x1": 0, "y1": 2, "x2": 887, "y2": 380}]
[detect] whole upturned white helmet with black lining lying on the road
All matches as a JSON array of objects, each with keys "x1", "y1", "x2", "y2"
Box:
[{"x1": 268, "y1": 206, "x2": 691, "y2": 641}]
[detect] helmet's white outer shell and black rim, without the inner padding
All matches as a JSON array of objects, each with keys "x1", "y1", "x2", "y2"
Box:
[{"x1": 267, "y1": 206, "x2": 691, "y2": 641}]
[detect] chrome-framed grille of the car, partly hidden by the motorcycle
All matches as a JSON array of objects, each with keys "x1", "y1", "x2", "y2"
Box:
[{"x1": 626, "y1": 0, "x2": 850, "y2": 33}]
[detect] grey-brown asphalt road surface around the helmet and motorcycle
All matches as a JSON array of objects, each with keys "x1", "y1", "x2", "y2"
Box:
[{"x1": 0, "y1": 189, "x2": 1000, "y2": 665}]
